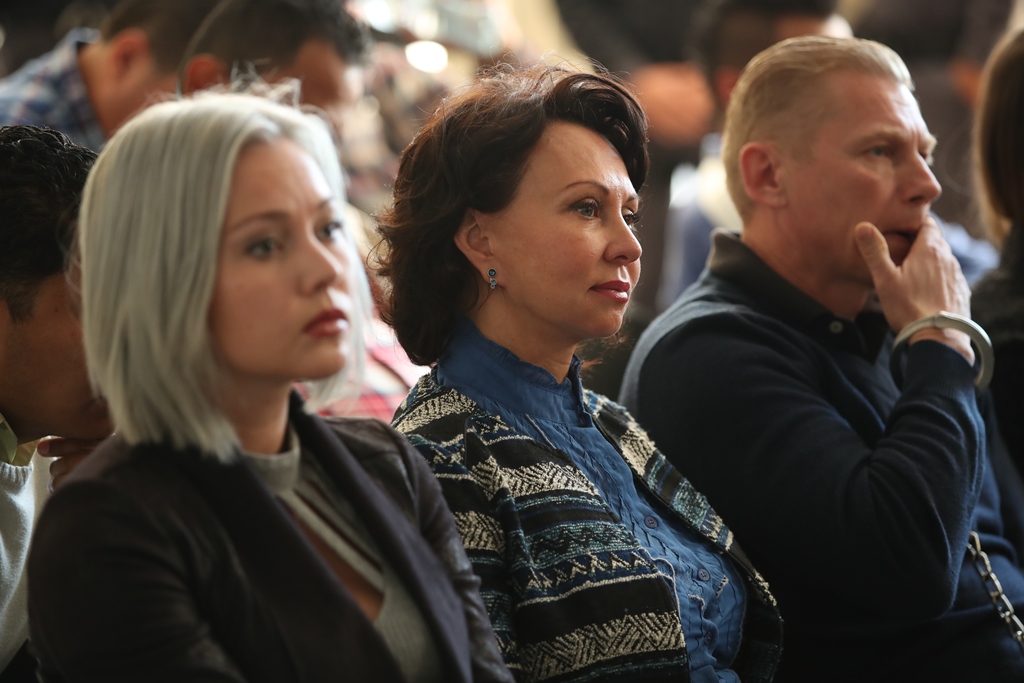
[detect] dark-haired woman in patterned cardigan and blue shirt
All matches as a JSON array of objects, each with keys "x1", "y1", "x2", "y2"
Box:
[{"x1": 379, "y1": 66, "x2": 781, "y2": 683}]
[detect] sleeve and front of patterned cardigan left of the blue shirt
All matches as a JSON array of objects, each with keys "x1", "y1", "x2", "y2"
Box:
[{"x1": 395, "y1": 378, "x2": 688, "y2": 681}]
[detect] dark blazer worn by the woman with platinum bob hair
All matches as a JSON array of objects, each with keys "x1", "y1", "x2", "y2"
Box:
[{"x1": 29, "y1": 397, "x2": 512, "y2": 683}]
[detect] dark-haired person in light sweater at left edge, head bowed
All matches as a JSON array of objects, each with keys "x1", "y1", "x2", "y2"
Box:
[{"x1": 0, "y1": 126, "x2": 112, "y2": 683}]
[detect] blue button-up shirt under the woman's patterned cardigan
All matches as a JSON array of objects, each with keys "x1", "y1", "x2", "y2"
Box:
[{"x1": 437, "y1": 318, "x2": 746, "y2": 683}]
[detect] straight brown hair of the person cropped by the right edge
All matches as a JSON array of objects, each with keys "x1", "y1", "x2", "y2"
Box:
[{"x1": 974, "y1": 32, "x2": 1024, "y2": 244}]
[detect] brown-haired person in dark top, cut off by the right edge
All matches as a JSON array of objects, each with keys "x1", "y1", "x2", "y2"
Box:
[{"x1": 971, "y1": 32, "x2": 1024, "y2": 472}]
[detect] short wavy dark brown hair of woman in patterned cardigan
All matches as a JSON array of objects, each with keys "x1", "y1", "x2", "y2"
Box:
[{"x1": 378, "y1": 65, "x2": 648, "y2": 365}]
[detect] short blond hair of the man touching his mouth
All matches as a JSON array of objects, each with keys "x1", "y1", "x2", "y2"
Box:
[{"x1": 722, "y1": 36, "x2": 913, "y2": 219}]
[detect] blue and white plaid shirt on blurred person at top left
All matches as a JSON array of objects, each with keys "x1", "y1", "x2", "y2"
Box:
[{"x1": 0, "y1": 29, "x2": 106, "y2": 152}]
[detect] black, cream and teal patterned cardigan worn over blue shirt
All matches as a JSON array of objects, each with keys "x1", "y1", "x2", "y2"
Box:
[{"x1": 394, "y1": 374, "x2": 781, "y2": 683}]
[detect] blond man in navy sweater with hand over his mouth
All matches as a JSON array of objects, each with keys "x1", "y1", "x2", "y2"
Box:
[{"x1": 624, "y1": 37, "x2": 1024, "y2": 683}]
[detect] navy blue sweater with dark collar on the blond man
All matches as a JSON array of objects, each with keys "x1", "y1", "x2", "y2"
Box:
[{"x1": 623, "y1": 236, "x2": 1024, "y2": 683}]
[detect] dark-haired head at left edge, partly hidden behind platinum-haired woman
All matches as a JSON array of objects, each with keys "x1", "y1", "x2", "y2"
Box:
[{"x1": 0, "y1": 126, "x2": 111, "y2": 443}]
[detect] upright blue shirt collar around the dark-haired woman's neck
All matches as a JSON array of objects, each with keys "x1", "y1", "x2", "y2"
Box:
[{"x1": 437, "y1": 317, "x2": 591, "y2": 426}]
